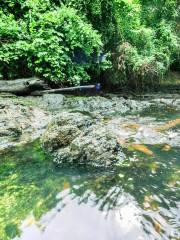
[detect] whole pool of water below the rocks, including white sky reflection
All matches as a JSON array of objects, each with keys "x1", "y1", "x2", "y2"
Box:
[{"x1": 0, "y1": 109, "x2": 180, "y2": 240}]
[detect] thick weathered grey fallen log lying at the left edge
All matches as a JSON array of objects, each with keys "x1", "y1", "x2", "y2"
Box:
[{"x1": 0, "y1": 77, "x2": 47, "y2": 94}]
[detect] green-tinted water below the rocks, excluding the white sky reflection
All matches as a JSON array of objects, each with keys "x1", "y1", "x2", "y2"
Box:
[{"x1": 0, "y1": 142, "x2": 180, "y2": 240}]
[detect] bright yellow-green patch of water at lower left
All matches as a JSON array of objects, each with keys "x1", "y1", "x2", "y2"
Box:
[{"x1": 0, "y1": 143, "x2": 62, "y2": 240}]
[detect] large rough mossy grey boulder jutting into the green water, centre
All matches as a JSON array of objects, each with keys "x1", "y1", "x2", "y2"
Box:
[{"x1": 42, "y1": 112, "x2": 125, "y2": 167}]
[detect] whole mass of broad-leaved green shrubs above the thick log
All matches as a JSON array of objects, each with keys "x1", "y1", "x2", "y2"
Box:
[{"x1": 0, "y1": 6, "x2": 102, "y2": 85}]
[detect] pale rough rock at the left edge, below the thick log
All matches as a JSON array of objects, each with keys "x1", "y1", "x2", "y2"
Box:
[{"x1": 0, "y1": 97, "x2": 50, "y2": 154}]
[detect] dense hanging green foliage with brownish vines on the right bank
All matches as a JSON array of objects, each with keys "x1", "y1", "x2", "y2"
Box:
[{"x1": 67, "y1": 0, "x2": 180, "y2": 87}]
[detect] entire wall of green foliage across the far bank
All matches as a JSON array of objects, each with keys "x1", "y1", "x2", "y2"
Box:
[{"x1": 0, "y1": 0, "x2": 180, "y2": 87}]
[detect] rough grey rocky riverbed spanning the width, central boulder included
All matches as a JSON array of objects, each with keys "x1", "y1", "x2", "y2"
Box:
[{"x1": 0, "y1": 94, "x2": 180, "y2": 167}]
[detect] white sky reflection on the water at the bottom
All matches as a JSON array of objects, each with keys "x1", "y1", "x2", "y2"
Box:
[{"x1": 17, "y1": 192, "x2": 144, "y2": 240}]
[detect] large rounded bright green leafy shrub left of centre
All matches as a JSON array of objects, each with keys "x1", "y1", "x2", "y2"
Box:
[{"x1": 28, "y1": 7, "x2": 102, "y2": 85}]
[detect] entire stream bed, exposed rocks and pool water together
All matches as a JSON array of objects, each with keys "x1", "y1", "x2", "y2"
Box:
[{"x1": 0, "y1": 94, "x2": 180, "y2": 240}]
